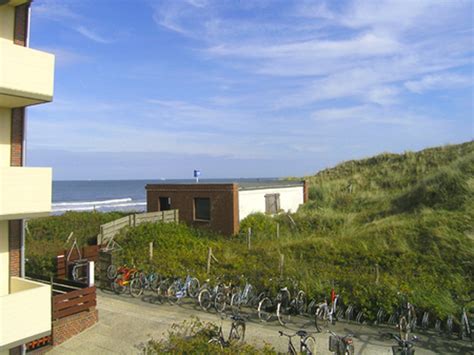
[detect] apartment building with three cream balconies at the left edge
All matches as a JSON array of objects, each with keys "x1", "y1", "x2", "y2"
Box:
[{"x1": 0, "y1": 0, "x2": 54, "y2": 354}]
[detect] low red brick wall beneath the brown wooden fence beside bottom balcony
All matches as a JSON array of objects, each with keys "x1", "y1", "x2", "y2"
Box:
[{"x1": 52, "y1": 307, "x2": 99, "y2": 346}]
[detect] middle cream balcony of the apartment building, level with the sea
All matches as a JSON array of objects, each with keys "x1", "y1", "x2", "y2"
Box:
[{"x1": 0, "y1": 167, "x2": 52, "y2": 220}]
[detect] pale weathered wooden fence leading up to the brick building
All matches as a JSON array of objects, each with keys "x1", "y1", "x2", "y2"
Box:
[{"x1": 97, "y1": 210, "x2": 179, "y2": 245}]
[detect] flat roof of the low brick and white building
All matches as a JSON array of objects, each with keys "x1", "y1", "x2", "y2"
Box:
[{"x1": 146, "y1": 179, "x2": 304, "y2": 190}]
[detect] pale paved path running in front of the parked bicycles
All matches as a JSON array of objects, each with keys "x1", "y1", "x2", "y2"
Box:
[{"x1": 50, "y1": 291, "x2": 474, "y2": 355}]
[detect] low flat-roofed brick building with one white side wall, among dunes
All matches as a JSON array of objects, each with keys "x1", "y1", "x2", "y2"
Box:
[{"x1": 146, "y1": 180, "x2": 308, "y2": 235}]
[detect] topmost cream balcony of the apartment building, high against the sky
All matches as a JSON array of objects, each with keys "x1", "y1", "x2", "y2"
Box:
[{"x1": 0, "y1": 38, "x2": 54, "y2": 108}]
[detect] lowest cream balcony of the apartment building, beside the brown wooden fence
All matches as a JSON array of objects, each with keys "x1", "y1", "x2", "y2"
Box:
[{"x1": 0, "y1": 277, "x2": 51, "y2": 351}]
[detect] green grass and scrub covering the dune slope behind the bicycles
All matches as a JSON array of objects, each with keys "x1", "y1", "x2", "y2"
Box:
[{"x1": 26, "y1": 142, "x2": 474, "y2": 318}]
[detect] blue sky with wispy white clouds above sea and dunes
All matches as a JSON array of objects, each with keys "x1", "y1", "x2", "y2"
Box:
[{"x1": 27, "y1": 0, "x2": 474, "y2": 180}]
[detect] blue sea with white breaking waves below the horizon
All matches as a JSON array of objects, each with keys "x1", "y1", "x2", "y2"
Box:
[{"x1": 52, "y1": 178, "x2": 277, "y2": 215}]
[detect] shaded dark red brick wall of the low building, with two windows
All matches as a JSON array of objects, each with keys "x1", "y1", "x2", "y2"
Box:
[{"x1": 146, "y1": 184, "x2": 239, "y2": 235}]
